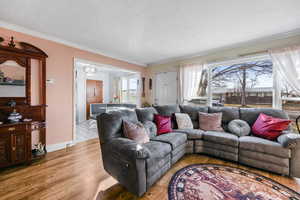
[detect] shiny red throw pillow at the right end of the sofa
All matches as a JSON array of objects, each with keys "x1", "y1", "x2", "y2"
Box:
[{"x1": 252, "y1": 113, "x2": 291, "y2": 140}]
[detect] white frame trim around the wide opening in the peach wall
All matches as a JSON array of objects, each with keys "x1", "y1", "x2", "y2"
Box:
[{"x1": 70, "y1": 57, "x2": 142, "y2": 142}]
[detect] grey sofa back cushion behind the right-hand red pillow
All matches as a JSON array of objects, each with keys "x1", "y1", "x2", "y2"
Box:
[{"x1": 240, "y1": 108, "x2": 289, "y2": 127}]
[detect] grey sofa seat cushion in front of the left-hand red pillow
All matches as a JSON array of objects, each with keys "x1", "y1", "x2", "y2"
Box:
[{"x1": 151, "y1": 132, "x2": 187, "y2": 149}]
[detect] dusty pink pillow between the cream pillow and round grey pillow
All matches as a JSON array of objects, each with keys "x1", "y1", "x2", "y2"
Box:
[{"x1": 199, "y1": 112, "x2": 224, "y2": 132}]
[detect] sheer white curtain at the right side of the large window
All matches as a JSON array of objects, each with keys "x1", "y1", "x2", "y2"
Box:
[{"x1": 269, "y1": 46, "x2": 300, "y2": 109}]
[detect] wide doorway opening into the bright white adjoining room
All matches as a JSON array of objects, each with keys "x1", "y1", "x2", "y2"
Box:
[{"x1": 73, "y1": 59, "x2": 141, "y2": 143}]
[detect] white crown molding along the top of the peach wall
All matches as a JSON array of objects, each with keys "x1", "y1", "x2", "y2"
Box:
[{"x1": 0, "y1": 20, "x2": 147, "y2": 67}]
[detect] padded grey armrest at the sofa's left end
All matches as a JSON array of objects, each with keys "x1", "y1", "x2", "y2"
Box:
[{"x1": 106, "y1": 138, "x2": 150, "y2": 160}]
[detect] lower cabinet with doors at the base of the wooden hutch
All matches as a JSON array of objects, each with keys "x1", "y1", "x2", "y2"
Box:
[{"x1": 0, "y1": 124, "x2": 31, "y2": 167}]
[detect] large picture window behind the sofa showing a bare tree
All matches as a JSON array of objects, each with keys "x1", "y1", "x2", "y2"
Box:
[{"x1": 183, "y1": 56, "x2": 300, "y2": 130}]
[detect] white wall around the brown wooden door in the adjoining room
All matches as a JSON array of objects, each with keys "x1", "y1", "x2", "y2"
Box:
[{"x1": 76, "y1": 67, "x2": 111, "y2": 123}]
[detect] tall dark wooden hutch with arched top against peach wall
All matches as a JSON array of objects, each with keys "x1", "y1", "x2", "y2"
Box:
[{"x1": 0, "y1": 37, "x2": 48, "y2": 168}]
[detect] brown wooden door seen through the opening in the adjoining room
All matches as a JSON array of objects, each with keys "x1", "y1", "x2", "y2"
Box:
[{"x1": 86, "y1": 79, "x2": 103, "y2": 120}]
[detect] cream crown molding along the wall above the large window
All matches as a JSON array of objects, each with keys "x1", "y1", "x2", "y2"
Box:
[{"x1": 148, "y1": 28, "x2": 300, "y2": 66}]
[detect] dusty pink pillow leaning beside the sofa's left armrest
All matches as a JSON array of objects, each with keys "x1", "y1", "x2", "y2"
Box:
[{"x1": 123, "y1": 121, "x2": 149, "y2": 144}]
